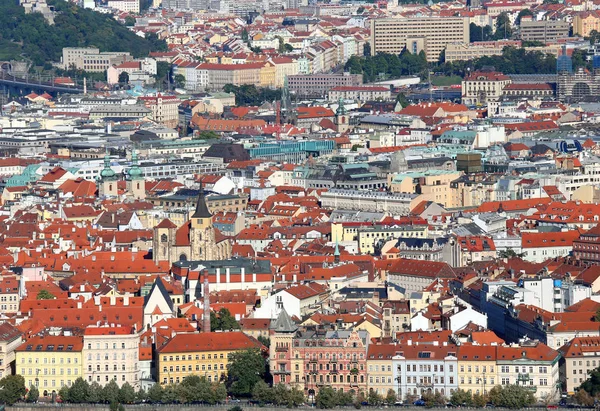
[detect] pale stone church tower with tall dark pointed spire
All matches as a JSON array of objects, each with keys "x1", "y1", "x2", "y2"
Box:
[{"x1": 190, "y1": 187, "x2": 217, "y2": 261}]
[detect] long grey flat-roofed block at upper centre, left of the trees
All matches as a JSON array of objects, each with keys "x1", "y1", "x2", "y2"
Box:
[{"x1": 288, "y1": 73, "x2": 363, "y2": 97}]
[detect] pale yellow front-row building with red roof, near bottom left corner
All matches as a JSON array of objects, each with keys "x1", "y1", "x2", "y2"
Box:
[{"x1": 15, "y1": 335, "x2": 83, "y2": 397}]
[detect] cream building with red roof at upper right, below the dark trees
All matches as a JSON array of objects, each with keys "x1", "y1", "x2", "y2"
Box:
[{"x1": 461, "y1": 71, "x2": 511, "y2": 105}]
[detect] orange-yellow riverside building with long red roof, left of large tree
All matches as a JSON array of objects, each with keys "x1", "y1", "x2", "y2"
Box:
[{"x1": 156, "y1": 331, "x2": 262, "y2": 385}]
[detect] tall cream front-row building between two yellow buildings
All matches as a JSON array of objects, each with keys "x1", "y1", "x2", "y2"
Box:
[{"x1": 83, "y1": 324, "x2": 140, "y2": 389}]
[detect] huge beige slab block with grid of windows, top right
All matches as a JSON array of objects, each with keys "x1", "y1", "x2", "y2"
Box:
[{"x1": 370, "y1": 17, "x2": 469, "y2": 62}]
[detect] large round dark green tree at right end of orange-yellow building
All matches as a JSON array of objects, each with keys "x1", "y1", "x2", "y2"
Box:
[{"x1": 227, "y1": 348, "x2": 265, "y2": 395}]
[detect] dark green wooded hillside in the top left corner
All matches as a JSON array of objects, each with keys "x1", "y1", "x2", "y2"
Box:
[{"x1": 0, "y1": 0, "x2": 166, "y2": 68}]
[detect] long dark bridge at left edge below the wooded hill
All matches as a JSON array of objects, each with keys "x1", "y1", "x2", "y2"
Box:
[{"x1": 0, "y1": 70, "x2": 83, "y2": 96}]
